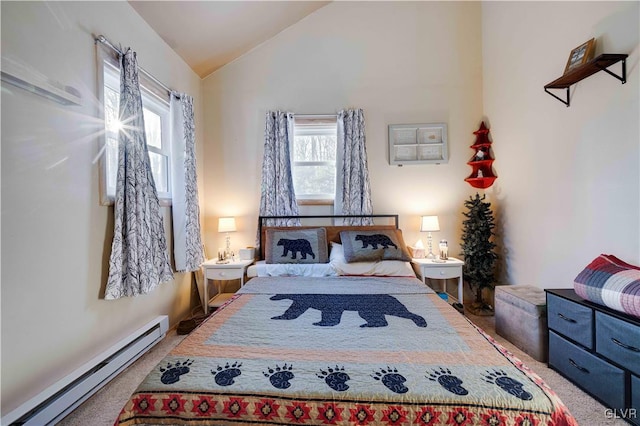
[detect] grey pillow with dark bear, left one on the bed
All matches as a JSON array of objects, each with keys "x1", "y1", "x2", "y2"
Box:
[{"x1": 264, "y1": 228, "x2": 329, "y2": 263}]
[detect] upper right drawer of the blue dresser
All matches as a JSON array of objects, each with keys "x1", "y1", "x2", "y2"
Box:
[{"x1": 596, "y1": 312, "x2": 640, "y2": 375}]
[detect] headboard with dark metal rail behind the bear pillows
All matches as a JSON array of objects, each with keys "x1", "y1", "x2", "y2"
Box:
[{"x1": 258, "y1": 214, "x2": 398, "y2": 260}]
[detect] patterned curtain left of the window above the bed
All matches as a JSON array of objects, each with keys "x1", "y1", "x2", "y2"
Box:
[{"x1": 258, "y1": 111, "x2": 300, "y2": 233}]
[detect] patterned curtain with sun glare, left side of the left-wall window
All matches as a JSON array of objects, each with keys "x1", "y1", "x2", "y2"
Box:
[{"x1": 105, "y1": 49, "x2": 173, "y2": 299}]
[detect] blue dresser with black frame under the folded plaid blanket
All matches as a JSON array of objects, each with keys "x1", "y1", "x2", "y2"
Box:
[{"x1": 546, "y1": 289, "x2": 640, "y2": 425}]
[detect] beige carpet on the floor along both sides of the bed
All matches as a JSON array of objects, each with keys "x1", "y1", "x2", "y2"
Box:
[{"x1": 59, "y1": 315, "x2": 628, "y2": 426}]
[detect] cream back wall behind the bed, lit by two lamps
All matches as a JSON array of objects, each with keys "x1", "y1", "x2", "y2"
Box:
[{"x1": 203, "y1": 2, "x2": 482, "y2": 254}]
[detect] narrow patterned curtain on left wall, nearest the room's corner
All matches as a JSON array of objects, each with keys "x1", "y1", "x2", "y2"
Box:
[{"x1": 170, "y1": 93, "x2": 204, "y2": 272}]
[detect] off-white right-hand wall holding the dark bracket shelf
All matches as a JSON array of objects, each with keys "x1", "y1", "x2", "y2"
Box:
[{"x1": 482, "y1": 2, "x2": 640, "y2": 288}]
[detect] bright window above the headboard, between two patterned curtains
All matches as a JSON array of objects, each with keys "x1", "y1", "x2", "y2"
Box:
[{"x1": 291, "y1": 117, "x2": 338, "y2": 204}]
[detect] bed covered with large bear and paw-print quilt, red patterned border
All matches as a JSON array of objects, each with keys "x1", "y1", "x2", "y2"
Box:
[{"x1": 116, "y1": 217, "x2": 577, "y2": 425}]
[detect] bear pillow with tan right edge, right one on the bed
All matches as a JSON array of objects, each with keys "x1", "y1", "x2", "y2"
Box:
[{"x1": 340, "y1": 229, "x2": 411, "y2": 262}]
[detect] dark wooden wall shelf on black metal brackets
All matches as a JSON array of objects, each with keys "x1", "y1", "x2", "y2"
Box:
[{"x1": 544, "y1": 53, "x2": 629, "y2": 107}]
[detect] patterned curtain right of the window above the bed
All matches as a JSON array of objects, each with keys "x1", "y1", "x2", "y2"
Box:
[{"x1": 334, "y1": 109, "x2": 373, "y2": 225}]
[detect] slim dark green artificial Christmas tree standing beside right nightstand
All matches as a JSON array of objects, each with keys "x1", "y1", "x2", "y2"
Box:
[{"x1": 461, "y1": 193, "x2": 498, "y2": 315}]
